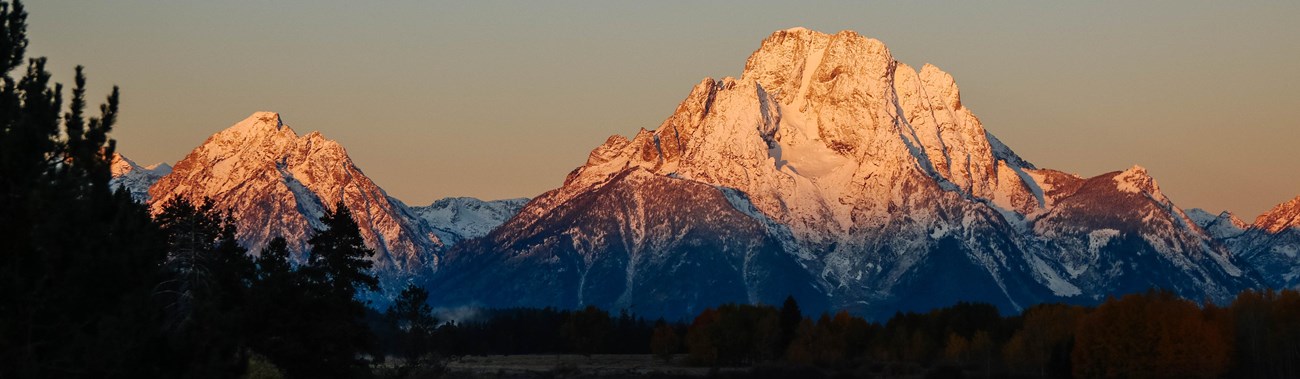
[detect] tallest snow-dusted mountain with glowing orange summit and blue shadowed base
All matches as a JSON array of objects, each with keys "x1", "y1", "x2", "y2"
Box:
[{"x1": 432, "y1": 29, "x2": 1257, "y2": 317}]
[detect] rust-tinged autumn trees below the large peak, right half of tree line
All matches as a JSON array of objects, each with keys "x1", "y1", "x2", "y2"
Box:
[{"x1": 651, "y1": 289, "x2": 1300, "y2": 378}]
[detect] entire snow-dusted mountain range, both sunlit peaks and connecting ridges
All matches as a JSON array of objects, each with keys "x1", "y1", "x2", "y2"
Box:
[{"x1": 113, "y1": 29, "x2": 1300, "y2": 317}]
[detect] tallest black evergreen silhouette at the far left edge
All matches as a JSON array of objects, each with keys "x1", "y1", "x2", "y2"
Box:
[{"x1": 0, "y1": 1, "x2": 163, "y2": 378}]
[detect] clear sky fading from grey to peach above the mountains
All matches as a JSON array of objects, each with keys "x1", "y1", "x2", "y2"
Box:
[{"x1": 27, "y1": 0, "x2": 1300, "y2": 221}]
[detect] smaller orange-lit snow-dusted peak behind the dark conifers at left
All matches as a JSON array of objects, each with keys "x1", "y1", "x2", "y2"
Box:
[{"x1": 150, "y1": 112, "x2": 442, "y2": 284}]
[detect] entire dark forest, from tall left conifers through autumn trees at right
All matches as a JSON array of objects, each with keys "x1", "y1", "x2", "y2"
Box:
[{"x1": 0, "y1": 1, "x2": 1300, "y2": 378}]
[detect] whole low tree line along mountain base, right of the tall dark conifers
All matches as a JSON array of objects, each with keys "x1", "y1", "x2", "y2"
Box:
[{"x1": 369, "y1": 289, "x2": 1300, "y2": 378}]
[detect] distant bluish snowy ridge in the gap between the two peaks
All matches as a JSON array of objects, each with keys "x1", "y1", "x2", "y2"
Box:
[{"x1": 411, "y1": 197, "x2": 528, "y2": 245}]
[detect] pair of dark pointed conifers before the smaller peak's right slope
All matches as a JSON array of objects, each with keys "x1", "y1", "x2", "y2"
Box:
[{"x1": 242, "y1": 202, "x2": 378, "y2": 378}]
